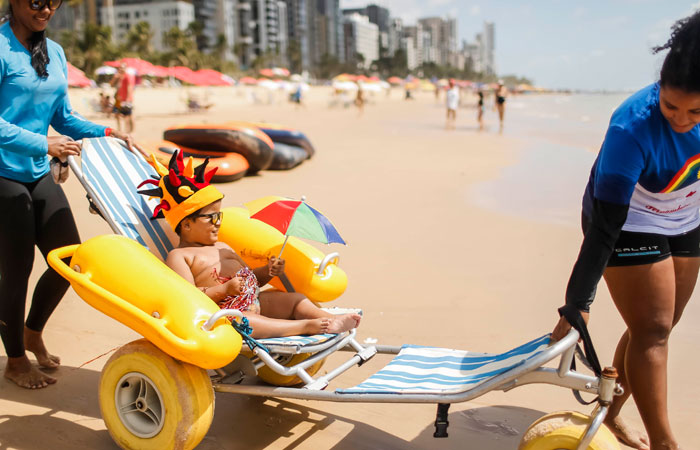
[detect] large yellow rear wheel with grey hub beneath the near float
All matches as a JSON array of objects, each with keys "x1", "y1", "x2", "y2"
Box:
[{"x1": 99, "y1": 339, "x2": 214, "y2": 450}]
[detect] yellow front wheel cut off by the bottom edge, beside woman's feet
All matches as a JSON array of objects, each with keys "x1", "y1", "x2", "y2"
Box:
[{"x1": 518, "y1": 411, "x2": 620, "y2": 450}]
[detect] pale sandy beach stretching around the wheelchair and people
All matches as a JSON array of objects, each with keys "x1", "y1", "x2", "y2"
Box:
[{"x1": 0, "y1": 83, "x2": 700, "y2": 450}]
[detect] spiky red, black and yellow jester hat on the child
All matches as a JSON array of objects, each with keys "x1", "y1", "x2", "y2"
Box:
[{"x1": 138, "y1": 150, "x2": 224, "y2": 230}]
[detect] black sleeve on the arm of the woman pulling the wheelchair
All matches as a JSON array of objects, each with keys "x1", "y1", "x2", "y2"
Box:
[{"x1": 566, "y1": 198, "x2": 629, "y2": 312}]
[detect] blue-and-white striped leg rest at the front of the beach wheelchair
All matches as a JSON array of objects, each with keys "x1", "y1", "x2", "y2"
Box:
[{"x1": 336, "y1": 334, "x2": 550, "y2": 394}]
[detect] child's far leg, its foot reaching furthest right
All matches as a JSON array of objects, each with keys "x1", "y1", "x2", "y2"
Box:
[{"x1": 260, "y1": 291, "x2": 362, "y2": 333}]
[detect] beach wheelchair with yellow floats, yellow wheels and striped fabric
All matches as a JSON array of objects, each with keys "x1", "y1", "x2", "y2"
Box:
[{"x1": 48, "y1": 138, "x2": 622, "y2": 450}]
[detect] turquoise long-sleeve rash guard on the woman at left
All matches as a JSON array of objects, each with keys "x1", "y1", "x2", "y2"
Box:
[{"x1": 0, "y1": 22, "x2": 106, "y2": 183}]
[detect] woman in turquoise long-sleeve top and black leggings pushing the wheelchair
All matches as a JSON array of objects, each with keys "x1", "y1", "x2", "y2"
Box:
[{"x1": 0, "y1": 0, "x2": 131, "y2": 389}]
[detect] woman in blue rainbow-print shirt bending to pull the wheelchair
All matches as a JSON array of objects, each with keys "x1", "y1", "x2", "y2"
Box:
[{"x1": 552, "y1": 12, "x2": 700, "y2": 450}]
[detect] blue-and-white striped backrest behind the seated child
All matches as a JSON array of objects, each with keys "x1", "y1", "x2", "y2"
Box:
[{"x1": 81, "y1": 137, "x2": 178, "y2": 260}]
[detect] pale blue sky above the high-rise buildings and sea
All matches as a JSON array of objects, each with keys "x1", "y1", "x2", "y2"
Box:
[{"x1": 340, "y1": 0, "x2": 700, "y2": 90}]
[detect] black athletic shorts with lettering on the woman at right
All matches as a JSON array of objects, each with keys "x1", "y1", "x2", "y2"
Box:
[{"x1": 581, "y1": 216, "x2": 700, "y2": 267}]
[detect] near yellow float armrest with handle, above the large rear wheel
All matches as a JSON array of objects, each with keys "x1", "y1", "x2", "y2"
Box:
[{"x1": 48, "y1": 235, "x2": 241, "y2": 369}]
